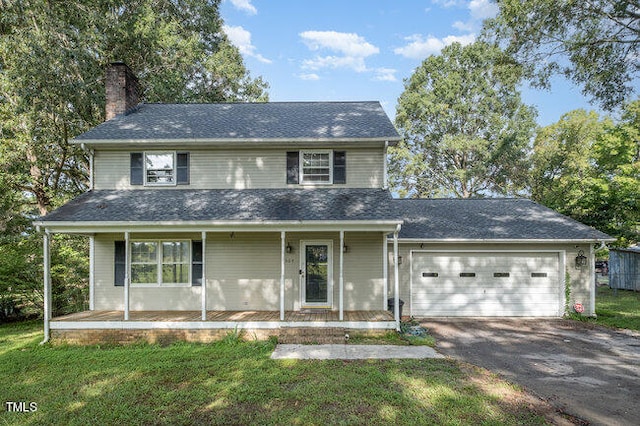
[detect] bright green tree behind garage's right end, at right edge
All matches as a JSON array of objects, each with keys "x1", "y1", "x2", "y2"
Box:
[{"x1": 531, "y1": 101, "x2": 640, "y2": 247}]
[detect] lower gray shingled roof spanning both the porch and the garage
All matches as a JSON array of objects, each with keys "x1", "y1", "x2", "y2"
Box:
[{"x1": 39, "y1": 188, "x2": 612, "y2": 241}]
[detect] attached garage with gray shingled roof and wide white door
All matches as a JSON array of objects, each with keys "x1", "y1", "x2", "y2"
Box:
[{"x1": 388, "y1": 198, "x2": 612, "y2": 317}]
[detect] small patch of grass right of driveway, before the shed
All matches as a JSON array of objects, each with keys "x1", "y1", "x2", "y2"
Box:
[{"x1": 596, "y1": 286, "x2": 640, "y2": 330}]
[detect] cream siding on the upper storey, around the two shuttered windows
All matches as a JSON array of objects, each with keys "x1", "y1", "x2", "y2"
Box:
[{"x1": 94, "y1": 148, "x2": 384, "y2": 190}]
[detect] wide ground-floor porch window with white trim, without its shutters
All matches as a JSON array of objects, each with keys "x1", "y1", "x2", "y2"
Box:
[{"x1": 131, "y1": 241, "x2": 191, "y2": 286}]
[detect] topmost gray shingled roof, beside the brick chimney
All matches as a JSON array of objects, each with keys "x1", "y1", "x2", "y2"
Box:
[{"x1": 75, "y1": 102, "x2": 400, "y2": 143}]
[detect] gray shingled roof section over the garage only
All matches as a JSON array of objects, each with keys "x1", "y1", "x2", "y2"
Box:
[{"x1": 394, "y1": 199, "x2": 612, "y2": 241}]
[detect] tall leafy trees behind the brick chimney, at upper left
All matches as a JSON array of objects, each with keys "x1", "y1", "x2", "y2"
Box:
[{"x1": 0, "y1": 0, "x2": 266, "y2": 214}]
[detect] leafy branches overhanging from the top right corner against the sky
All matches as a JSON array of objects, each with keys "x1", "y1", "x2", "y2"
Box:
[{"x1": 485, "y1": 0, "x2": 640, "y2": 109}]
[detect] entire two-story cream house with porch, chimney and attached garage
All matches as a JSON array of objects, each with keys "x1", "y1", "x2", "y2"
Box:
[{"x1": 36, "y1": 63, "x2": 610, "y2": 340}]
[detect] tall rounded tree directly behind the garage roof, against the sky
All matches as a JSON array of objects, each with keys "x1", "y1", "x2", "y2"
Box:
[{"x1": 390, "y1": 42, "x2": 535, "y2": 198}]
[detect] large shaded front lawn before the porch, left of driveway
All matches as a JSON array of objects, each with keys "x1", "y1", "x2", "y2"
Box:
[{"x1": 0, "y1": 323, "x2": 548, "y2": 425}]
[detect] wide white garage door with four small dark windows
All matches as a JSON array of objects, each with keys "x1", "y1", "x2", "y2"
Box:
[{"x1": 411, "y1": 252, "x2": 564, "y2": 317}]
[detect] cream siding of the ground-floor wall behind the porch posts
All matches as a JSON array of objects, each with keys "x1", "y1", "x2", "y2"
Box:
[{"x1": 95, "y1": 232, "x2": 386, "y2": 311}]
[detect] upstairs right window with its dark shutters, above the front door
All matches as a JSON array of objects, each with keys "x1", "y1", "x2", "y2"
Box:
[{"x1": 287, "y1": 150, "x2": 347, "y2": 185}]
